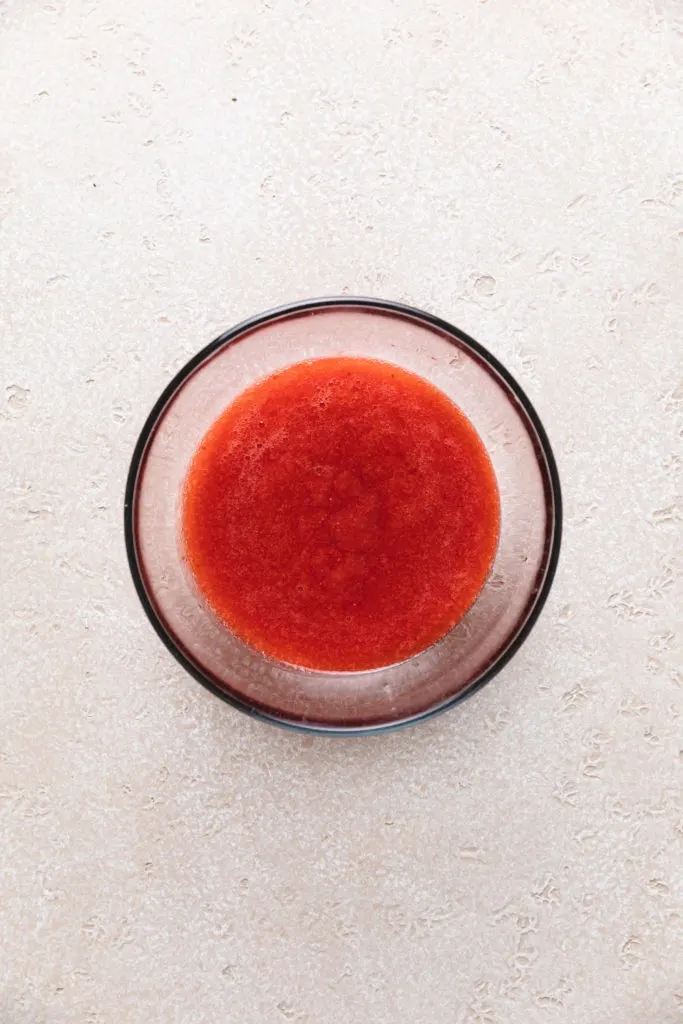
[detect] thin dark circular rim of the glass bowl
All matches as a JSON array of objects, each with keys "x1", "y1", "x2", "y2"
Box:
[{"x1": 123, "y1": 295, "x2": 562, "y2": 736}]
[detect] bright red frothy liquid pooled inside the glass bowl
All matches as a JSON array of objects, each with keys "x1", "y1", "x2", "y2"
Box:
[{"x1": 182, "y1": 357, "x2": 500, "y2": 672}]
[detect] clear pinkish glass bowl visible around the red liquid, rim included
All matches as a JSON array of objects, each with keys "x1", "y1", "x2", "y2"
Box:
[{"x1": 124, "y1": 297, "x2": 562, "y2": 733}]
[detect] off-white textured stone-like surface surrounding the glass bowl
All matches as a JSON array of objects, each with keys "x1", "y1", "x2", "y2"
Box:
[{"x1": 0, "y1": 0, "x2": 683, "y2": 1024}]
